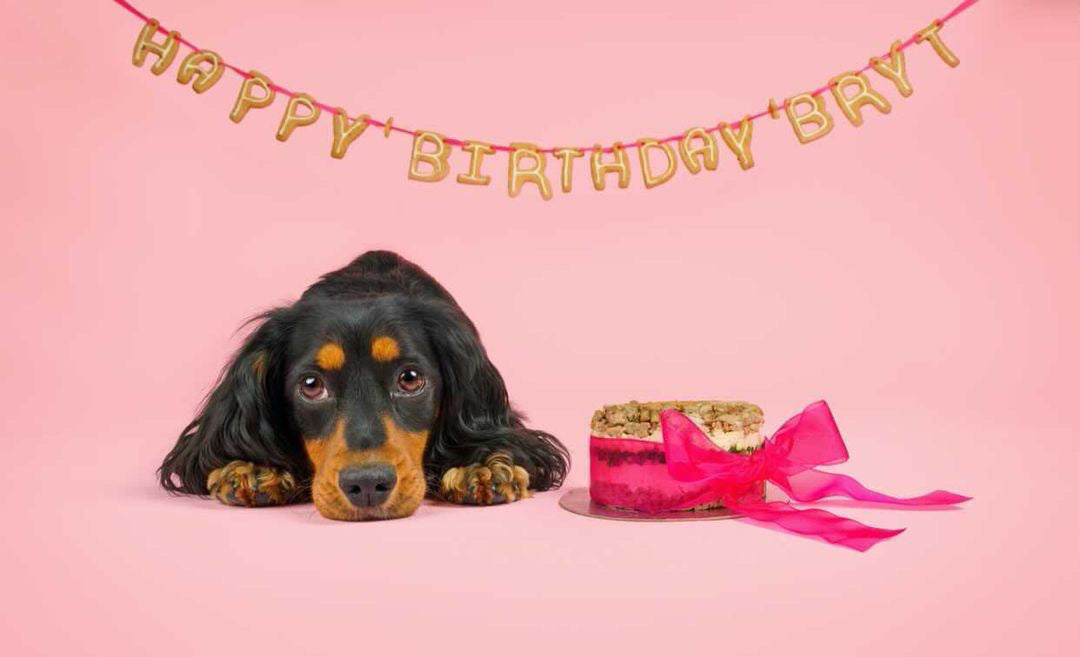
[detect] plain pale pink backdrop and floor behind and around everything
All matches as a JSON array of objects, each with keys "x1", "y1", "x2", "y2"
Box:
[{"x1": 0, "y1": 0, "x2": 1080, "y2": 656}]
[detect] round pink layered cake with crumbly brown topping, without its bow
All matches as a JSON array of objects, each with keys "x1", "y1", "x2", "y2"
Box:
[{"x1": 589, "y1": 401, "x2": 765, "y2": 513}]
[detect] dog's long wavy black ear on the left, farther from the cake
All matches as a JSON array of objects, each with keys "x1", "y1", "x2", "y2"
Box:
[{"x1": 158, "y1": 308, "x2": 310, "y2": 495}]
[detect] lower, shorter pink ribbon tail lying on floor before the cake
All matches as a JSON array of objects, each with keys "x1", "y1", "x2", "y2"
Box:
[{"x1": 731, "y1": 501, "x2": 904, "y2": 552}]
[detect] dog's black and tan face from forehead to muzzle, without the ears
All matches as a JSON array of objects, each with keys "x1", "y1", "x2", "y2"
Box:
[{"x1": 280, "y1": 297, "x2": 442, "y2": 520}]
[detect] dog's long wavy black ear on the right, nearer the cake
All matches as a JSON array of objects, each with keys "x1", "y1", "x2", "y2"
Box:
[{"x1": 421, "y1": 301, "x2": 570, "y2": 491}]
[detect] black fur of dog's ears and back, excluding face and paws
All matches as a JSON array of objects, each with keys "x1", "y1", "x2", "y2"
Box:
[{"x1": 159, "y1": 251, "x2": 569, "y2": 499}]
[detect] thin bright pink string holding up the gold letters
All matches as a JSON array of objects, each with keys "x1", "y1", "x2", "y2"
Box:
[{"x1": 113, "y1": 0, "x2": 978, "y2": 153}]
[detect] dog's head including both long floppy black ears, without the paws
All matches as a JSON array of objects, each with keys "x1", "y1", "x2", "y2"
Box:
[{"x1": 161, "y1": 295, "x2": 565, "y2": 520}]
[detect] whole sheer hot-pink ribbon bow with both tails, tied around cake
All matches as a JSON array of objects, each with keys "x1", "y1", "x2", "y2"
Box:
[{"x1": 660, "y1": 401, "x2": 971, "y2": 551}]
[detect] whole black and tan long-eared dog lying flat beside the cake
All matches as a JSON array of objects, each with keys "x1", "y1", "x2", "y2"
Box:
[{"x1": 158, "y1": 251, "x2": 569, "y2": 520}]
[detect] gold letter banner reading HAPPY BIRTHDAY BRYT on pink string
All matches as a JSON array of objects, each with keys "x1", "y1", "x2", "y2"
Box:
[{"x1": 114, "y1": 0, "x2": 977, "y2": 201}]
